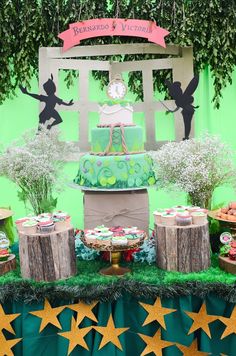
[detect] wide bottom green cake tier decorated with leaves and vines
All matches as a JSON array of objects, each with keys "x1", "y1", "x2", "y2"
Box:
[{"x1": 74, "y1": 153, "x2": 156, "y2": 189}]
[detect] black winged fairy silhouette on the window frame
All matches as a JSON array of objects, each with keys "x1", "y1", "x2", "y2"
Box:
[{"x1": 162, "y1": 75, "x2": 199, "y2": 140}]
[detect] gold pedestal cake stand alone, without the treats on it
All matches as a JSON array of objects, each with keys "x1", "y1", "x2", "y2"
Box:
[{"x1": 81, "y1": 234, "x2": 147, "y2": 277}]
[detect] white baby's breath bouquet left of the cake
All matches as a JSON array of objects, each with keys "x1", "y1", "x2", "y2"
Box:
[{"x1": 0, "y1": 126, "x2": 79, "y2": 215}]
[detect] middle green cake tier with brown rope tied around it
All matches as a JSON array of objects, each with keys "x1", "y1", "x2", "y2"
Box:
[{"x1": 91, "y1": 126, "x2": 144, "y2": 153}]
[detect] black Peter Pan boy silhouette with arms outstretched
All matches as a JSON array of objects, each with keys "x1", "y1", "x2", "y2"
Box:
[{"x1": 20, "y1": 74, "x2": 74, "y2": 130}]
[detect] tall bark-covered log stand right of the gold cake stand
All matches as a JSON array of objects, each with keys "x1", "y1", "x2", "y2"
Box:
[{"x1": 155, "y1": 223, "x2": 210, "y2": 273}]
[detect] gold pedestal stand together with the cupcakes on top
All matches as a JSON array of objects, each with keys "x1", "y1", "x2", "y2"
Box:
[{"x1": 81, "y1": 225, "x2": 147, "y2": 276}]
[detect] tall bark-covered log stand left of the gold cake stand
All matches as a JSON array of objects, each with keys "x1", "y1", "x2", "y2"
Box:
[{"x1": 19, "y1": 228, "x2": 77, "y2": 281}]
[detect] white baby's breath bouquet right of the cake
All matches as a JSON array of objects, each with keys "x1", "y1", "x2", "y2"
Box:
[{"x1": 150, "y1": 134, "x2": 236, "y2": 209}]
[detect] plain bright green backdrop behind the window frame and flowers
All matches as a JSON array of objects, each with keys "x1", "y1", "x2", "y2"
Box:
[{"x1": 0, "y1": 68, "x2": 236, "y2": 234}]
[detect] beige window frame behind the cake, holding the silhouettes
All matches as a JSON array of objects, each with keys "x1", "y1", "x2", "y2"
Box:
[{"x1": 39, "y1": 43, "x2": 194, "y2": 151}]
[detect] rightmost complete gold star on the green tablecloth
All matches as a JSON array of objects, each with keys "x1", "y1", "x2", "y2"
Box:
[{"x1": 185, "y1": 303, "x2": 219, "y2": 338}]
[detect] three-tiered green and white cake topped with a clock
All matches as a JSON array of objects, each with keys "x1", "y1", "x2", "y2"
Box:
[{"x1": 74, "y1": 77, "x2": 155, "y2": 189}]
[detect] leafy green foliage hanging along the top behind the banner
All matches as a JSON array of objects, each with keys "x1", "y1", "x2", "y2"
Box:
[{"x1": 0, "y1": 0, "x2": 236, "y2": 107}]
